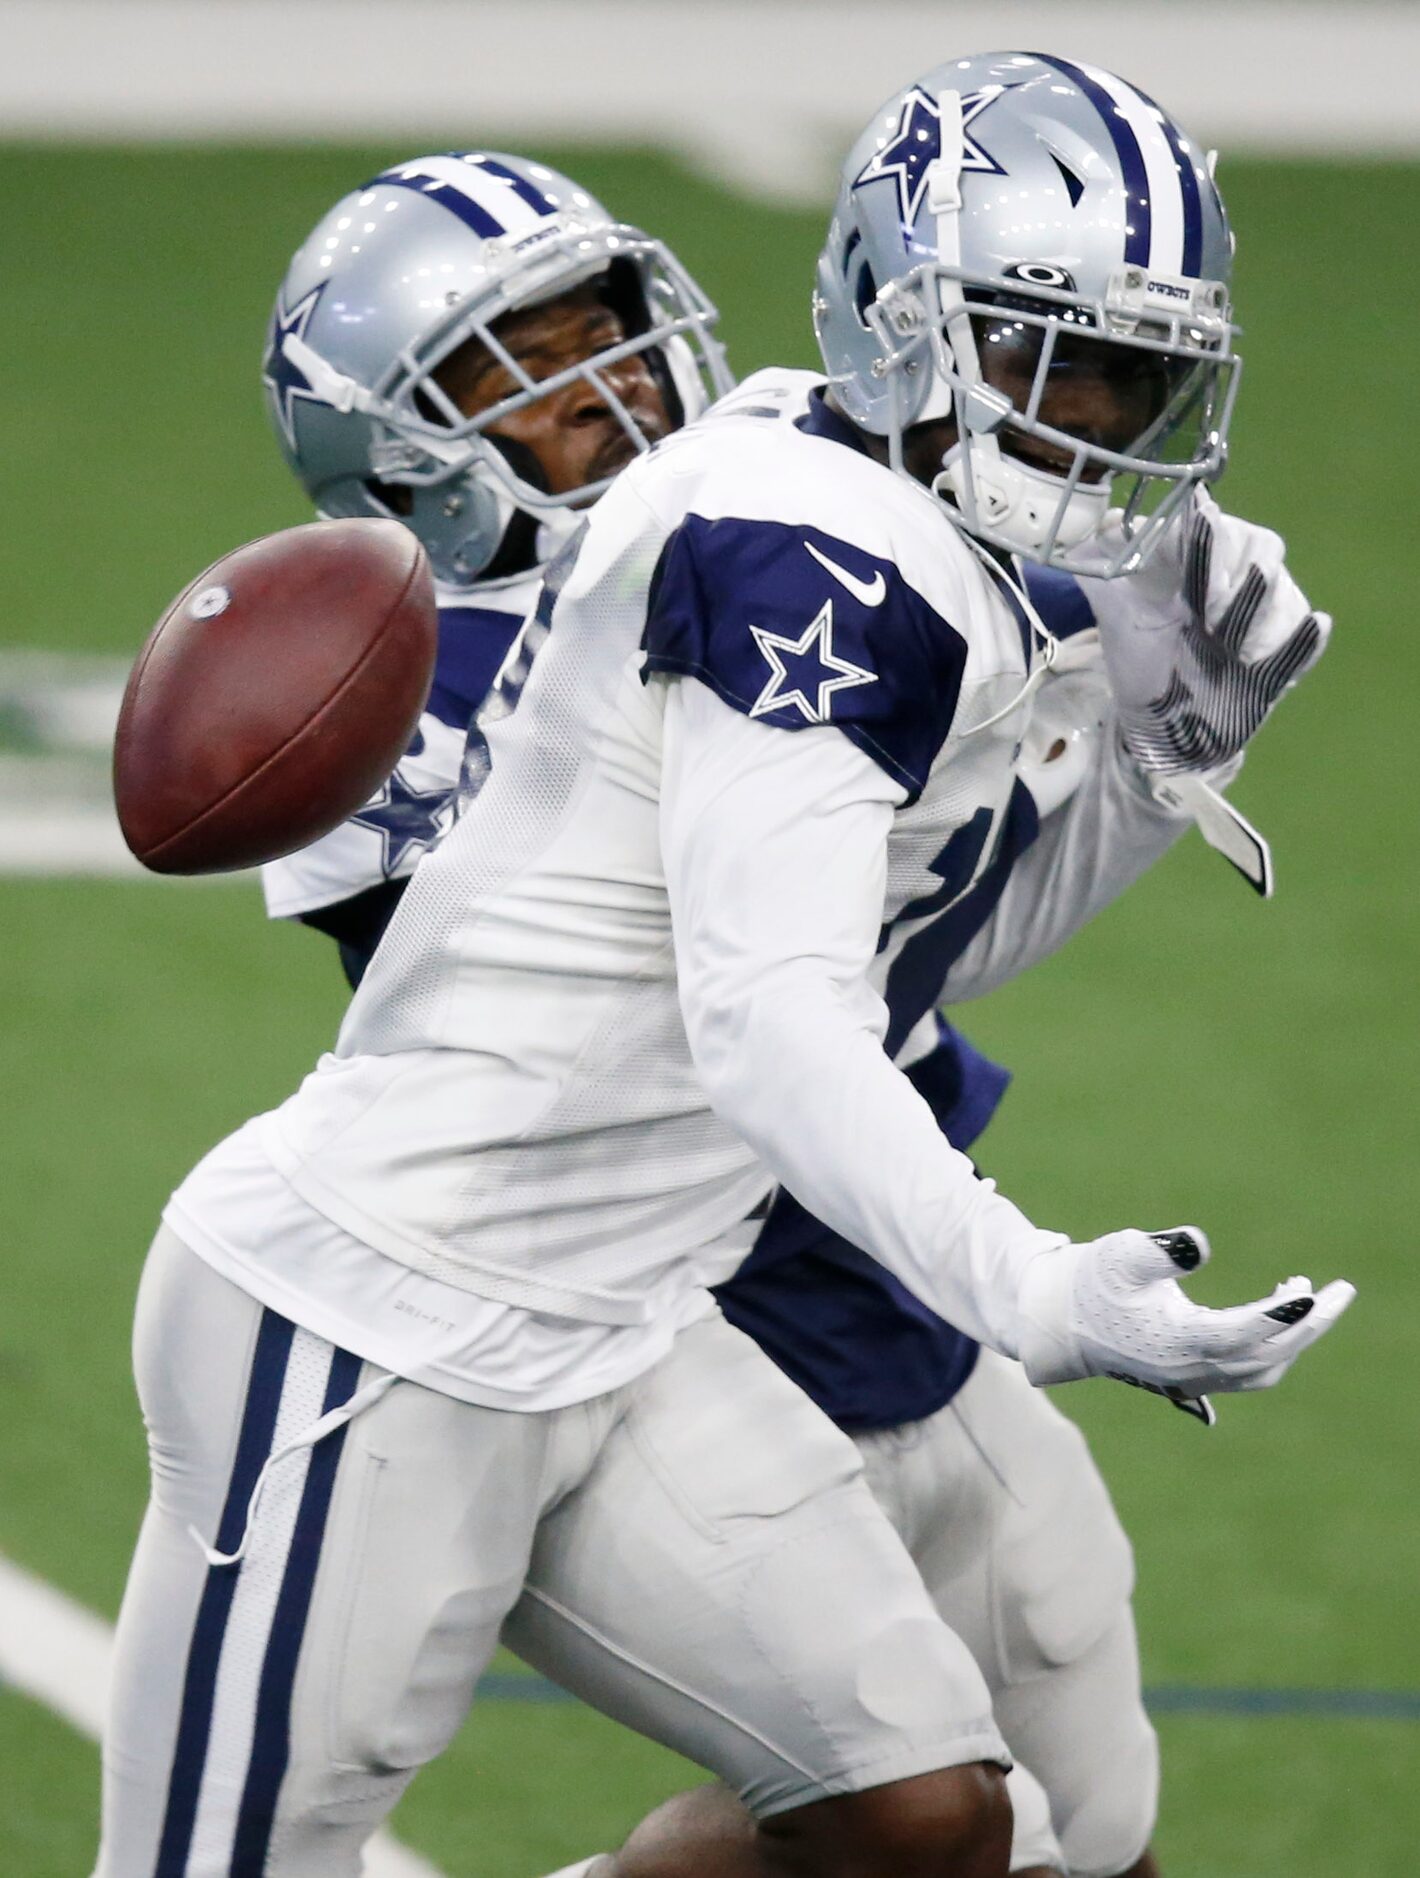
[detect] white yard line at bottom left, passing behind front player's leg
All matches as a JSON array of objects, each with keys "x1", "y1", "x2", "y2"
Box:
[{"x1": 0, "y1": 1557, "x2": 441, "y2": 1878}]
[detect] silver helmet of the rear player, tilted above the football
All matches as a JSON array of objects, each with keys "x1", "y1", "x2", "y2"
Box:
[{"x1": 261, "y1": 150, "x2": 733, "y2": 584}]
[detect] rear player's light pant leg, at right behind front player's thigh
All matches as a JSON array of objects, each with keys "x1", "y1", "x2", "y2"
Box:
[{"x1": 857, "y1": 1350, "x2": 1159, "y2": 1878}]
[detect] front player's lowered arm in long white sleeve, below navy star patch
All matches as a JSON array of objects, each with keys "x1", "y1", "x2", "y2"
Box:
[{"x1": 661, "y1": 678, "x2": 1065, "y2": 1354}]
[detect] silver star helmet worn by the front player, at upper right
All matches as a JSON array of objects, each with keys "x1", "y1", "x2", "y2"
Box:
[{"x1": 813, "y1": 53, "x2": 1240, "y2": 575}]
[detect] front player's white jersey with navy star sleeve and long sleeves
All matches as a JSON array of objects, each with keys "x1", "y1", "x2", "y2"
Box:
[{"x1": 174, "y1": 374, "x2": 1180, "y2": 1397}]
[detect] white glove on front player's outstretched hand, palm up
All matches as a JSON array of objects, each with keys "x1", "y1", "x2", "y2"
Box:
[{"x1": 1016, "y1": 1226, "x2": 1356, "y2": 1399}]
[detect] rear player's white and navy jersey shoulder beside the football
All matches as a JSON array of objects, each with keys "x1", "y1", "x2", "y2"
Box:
[{"x1": 261, "y1": 567, "x2": 543, "y2": 920}]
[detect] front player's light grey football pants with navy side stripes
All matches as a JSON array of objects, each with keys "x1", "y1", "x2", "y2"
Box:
[{"x1": 98, "y1": 1228, "x2": 1009, "y2": 1878}]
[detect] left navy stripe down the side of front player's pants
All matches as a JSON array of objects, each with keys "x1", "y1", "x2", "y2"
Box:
[{"x1": 154, "y1": 1311, "x2": 295, "y2": 1878}]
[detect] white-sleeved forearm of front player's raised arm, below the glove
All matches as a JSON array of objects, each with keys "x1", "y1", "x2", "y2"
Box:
[{"x1": 943, "y1": 723, "x2": 1193, "y2": 1003}]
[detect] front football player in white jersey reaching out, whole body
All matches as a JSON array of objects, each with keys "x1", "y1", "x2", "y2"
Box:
[{"x1": 101, "y1": 54, "x2": 1349, "y2": 1878}]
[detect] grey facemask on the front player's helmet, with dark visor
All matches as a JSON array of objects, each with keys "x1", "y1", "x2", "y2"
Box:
[{"x1": 864, "y1": 263, "x2": 1240, "y2": 577}]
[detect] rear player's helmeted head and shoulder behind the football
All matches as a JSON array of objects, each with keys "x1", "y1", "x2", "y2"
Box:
[{"x1": 263, "y1": 150, "x2": 731, "y2": 984}]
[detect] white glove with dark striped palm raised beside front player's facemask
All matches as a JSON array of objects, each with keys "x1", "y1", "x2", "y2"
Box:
[{"x1": 1080, "y1": 488, "x2": 1332, "y2": 772}]
